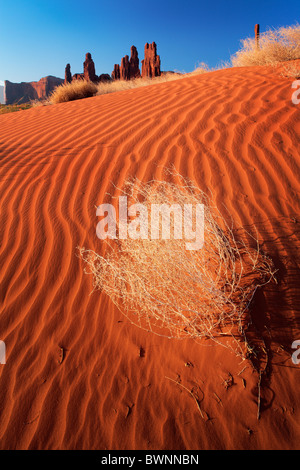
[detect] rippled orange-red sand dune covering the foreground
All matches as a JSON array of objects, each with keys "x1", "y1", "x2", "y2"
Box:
[{"x1": 0, "y1": 67, "x2": 300, "y2": 450}]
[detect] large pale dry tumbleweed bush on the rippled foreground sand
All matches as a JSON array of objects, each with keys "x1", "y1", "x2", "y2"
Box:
[{"x1": 79, "y1": 176, "x2": 274, "y2": 357}]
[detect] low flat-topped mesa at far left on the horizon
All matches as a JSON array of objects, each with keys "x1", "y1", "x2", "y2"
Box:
[{"x1": 4, "y1": 75, "x2": 64, "y2": 104}]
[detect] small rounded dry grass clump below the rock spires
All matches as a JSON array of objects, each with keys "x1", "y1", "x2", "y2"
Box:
[{"x1": 49, "y1": 80, "x2": 97, "y2": 104}]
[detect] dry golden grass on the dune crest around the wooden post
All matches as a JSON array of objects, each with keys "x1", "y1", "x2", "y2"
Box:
[{"x1": 231, "y1": 24, "x2": 300, "y2": 67}]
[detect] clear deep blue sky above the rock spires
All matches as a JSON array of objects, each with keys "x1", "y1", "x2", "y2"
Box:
[{"x1": 0, "y1": 0, "x2": 300, "y2": 84}]
